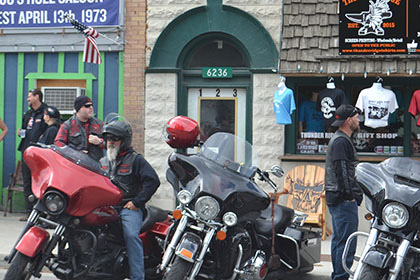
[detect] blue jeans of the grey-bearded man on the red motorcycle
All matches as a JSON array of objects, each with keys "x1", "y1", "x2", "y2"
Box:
[{"x1": 120, "y1": 208, "x2": 144, "y2": 280}]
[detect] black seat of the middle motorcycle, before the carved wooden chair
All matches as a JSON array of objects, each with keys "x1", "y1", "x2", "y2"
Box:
[{"x1": 255, "y1": 204, "x2": 294, "y2": 236}]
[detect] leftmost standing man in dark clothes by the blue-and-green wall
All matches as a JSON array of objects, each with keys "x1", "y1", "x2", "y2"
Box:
[{"x1": 17, "y1": 89, "x2": 47, "y2": 221}]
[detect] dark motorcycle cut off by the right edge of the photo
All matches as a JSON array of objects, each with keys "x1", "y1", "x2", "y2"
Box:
[{"x1": 342, "y1": 157, "x2": 420, "y2": 280}]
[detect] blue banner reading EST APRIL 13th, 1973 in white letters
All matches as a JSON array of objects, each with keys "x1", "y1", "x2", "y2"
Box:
[{"x1": 0, "y1": 0, "x2": 120, "y2": 29}]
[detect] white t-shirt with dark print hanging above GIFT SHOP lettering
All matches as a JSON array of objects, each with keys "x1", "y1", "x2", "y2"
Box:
[{"x1": 356, "y1": 84, "x2": 398, "y2": 128}]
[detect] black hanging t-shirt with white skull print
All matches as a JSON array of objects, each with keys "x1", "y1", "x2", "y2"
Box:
[{"x1": 316, "y1": 88, "x2": 349, "y2": 126}]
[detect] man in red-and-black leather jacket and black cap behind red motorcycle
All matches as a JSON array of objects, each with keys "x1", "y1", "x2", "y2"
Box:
[{"x1": 54, "y1": 96, "x2": 105, "y2": 161}]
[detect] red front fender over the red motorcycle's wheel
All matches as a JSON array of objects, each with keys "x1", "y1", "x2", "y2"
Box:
[{"x1": 16, "y1": 226, "x2": 50, "y2": 258}]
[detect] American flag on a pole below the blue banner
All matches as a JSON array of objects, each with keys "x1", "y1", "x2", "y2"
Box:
[{"x1": 65, "y1": 16, "x2": 102, "y2": 64}]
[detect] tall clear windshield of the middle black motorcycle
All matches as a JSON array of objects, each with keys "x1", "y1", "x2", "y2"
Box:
[{"x1": 200, "y1": 132, "x2": 258, "y2": 177}]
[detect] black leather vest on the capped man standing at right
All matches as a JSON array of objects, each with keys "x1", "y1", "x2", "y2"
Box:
[{"x1": 325, "y1": 130, "x2": 359, "y2": 192}]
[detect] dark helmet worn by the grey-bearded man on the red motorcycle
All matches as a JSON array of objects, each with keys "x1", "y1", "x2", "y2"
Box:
[{"x1": 102, "y1": 113, "x2": 133, "y2": 152}]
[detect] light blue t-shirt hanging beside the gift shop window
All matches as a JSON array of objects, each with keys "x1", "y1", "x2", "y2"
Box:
[{"x1": 273, "y1": 88, "x2": 296, "y2": 124}]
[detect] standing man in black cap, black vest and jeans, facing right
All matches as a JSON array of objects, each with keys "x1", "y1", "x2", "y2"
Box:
[{"x1": 325, "y1": 105, "x2": 363, "y2": 280}]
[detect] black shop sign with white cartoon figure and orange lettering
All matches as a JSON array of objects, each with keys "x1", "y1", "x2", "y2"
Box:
[{"x1": 339, "y1": 0, "x2": 420, "y2": 55}]
